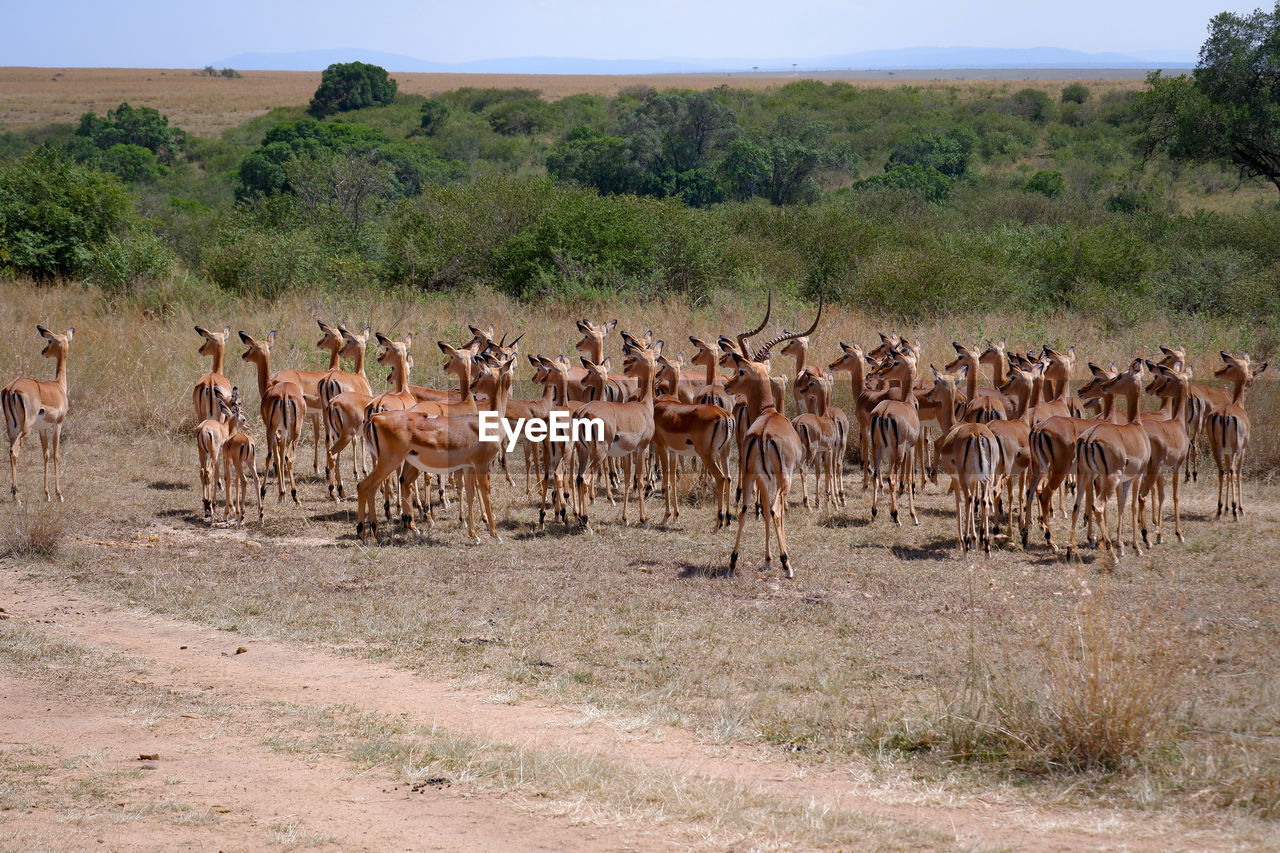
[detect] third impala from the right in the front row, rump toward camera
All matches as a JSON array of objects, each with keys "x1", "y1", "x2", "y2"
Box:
[{"x1": 1066, "y1": 359, "x2": 1151, "y2": 560}]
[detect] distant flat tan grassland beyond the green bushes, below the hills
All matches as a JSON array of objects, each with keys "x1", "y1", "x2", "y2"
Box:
[{"x1": 0, "y1": 67, "x2": 1142, "y2": 137}]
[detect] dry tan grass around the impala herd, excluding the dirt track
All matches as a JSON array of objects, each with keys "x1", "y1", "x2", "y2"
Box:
[{"x1": 0, "y1": 277, "x2": 1280, "y2": 816}]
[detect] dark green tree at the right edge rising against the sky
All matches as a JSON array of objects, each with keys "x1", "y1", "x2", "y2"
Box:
[{"x1": 1139, "y1": 3, "x2": 1280, "y2": 190}]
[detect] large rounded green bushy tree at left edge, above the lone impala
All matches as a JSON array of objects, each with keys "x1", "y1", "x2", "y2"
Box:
[{"x1": 0, "y1": 147, "x2": 131, "y2": 280}]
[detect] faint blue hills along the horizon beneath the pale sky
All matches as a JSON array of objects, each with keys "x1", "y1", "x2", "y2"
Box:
[{"x1": 212, "y1": 47, "x2": 1196, "y2": 74}]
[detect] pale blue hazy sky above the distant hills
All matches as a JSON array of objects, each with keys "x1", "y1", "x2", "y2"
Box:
[{"x1": 0, "y1": 0, "x2": 1239, "y2": 68}]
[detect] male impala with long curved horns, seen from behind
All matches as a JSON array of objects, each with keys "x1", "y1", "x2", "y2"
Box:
[{"x1": 724, "y1": 292, "x2": 822, "y2": 578}]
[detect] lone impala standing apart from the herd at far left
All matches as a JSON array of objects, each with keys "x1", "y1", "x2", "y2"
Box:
[{"x1": 0, "y1": 325, "x2": 76, "y2": 503}]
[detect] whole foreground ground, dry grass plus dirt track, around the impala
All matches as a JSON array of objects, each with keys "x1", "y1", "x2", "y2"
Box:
[{"x1": 0, "y1": 283, "x2": 1280, "y2": 850}]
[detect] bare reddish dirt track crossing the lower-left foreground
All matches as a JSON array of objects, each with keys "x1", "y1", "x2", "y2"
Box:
[{"x1": 0, "y1": 569, "x2": 1230, "y2": 850}]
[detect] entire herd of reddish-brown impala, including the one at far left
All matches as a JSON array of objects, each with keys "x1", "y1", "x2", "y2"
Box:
[{"x1": 0, "y1": 297, "x2": 1267, "y2": 576}]
